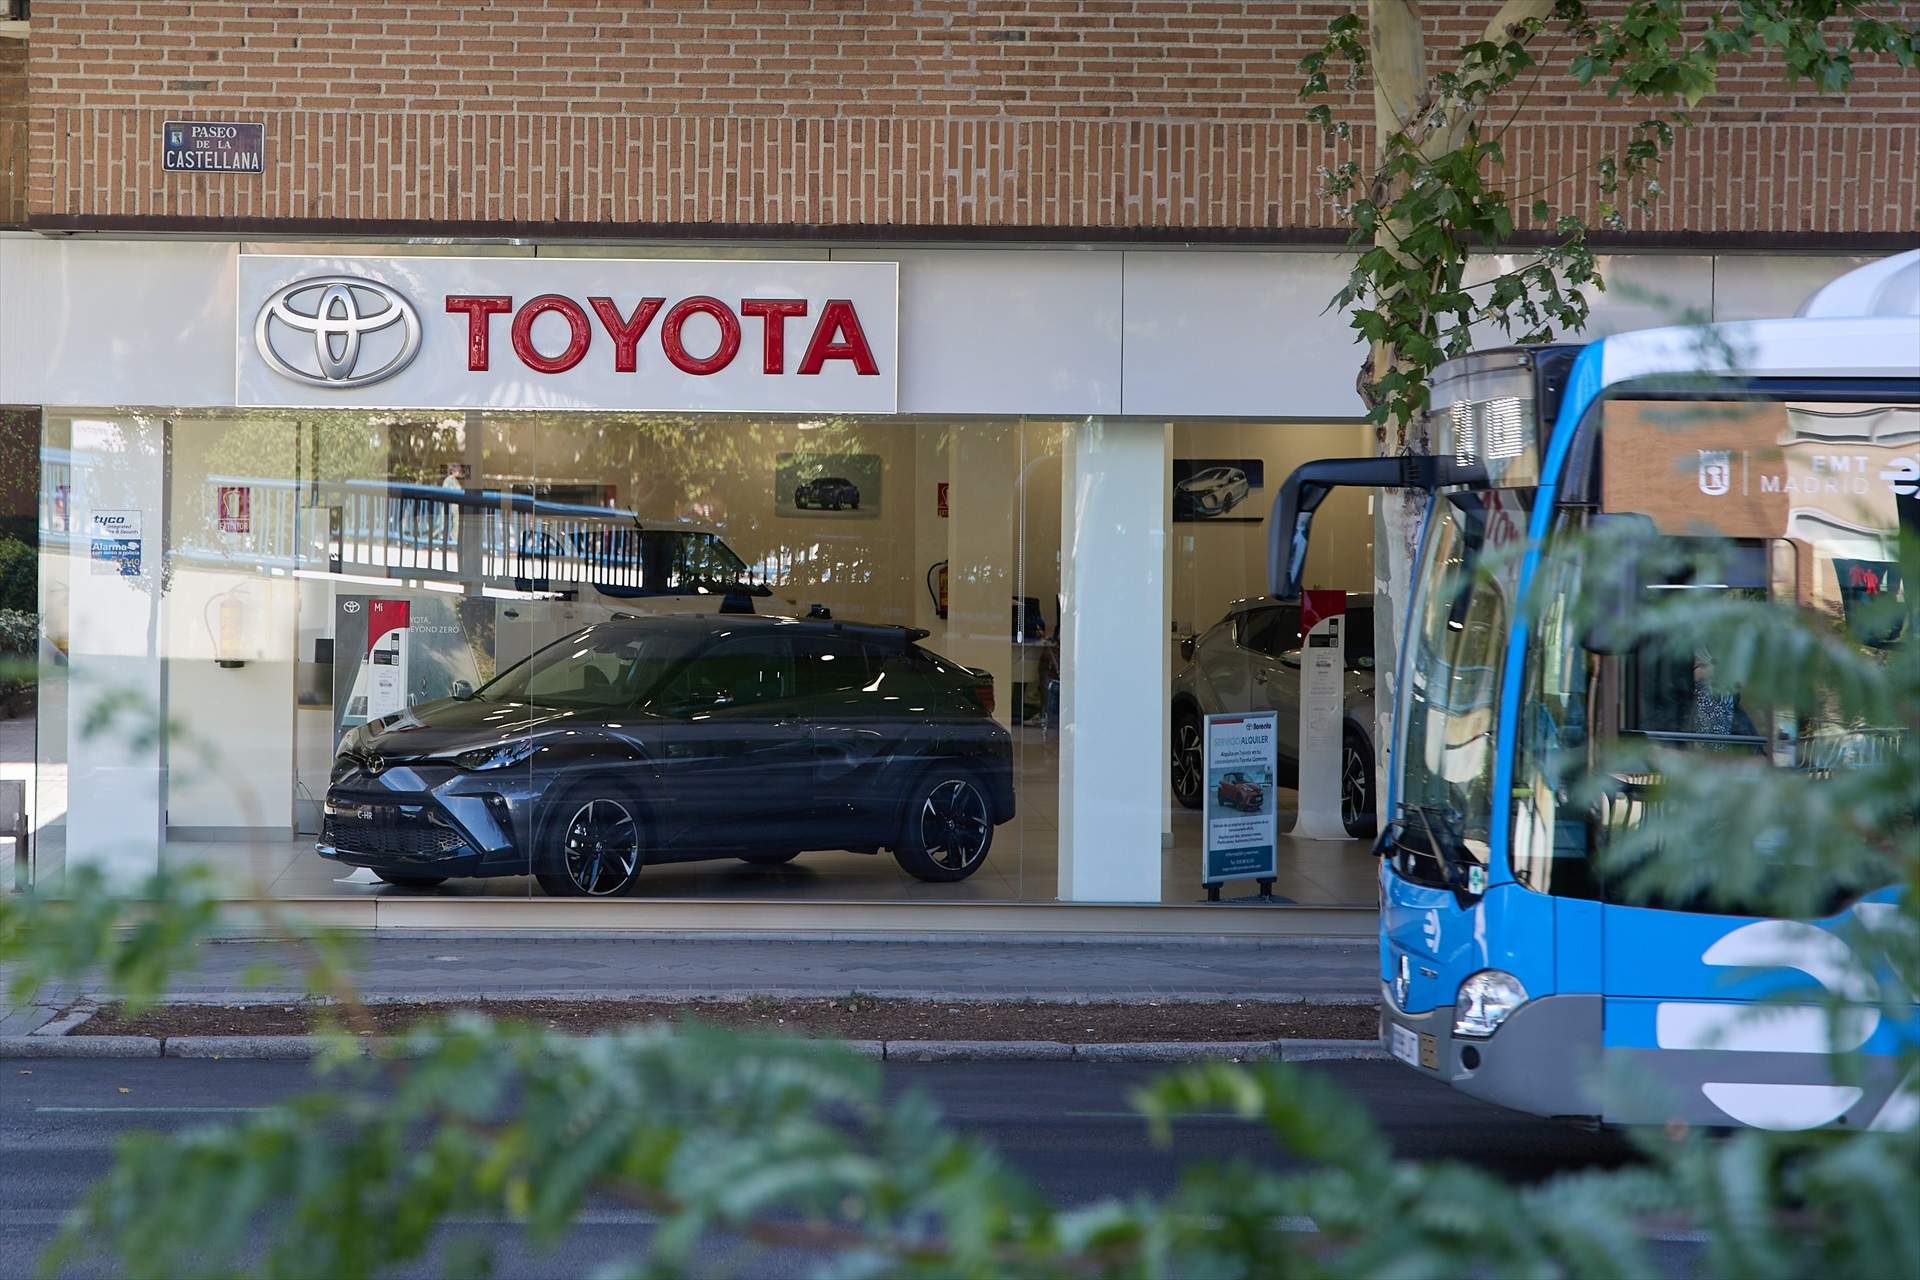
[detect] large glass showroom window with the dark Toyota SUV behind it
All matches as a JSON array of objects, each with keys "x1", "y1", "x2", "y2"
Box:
[{"x1": 40, "y1": 411, "x2": 1071, "y2": 900}]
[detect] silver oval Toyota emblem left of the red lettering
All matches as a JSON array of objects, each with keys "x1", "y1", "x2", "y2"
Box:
[{"x1": 253, "y1": 276, "x2": 420, "y2": 388}]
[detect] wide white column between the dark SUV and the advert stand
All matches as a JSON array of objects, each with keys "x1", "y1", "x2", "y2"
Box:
[{"x1": 1060, "y1": 420, "x2": 1169, "y2": 902}]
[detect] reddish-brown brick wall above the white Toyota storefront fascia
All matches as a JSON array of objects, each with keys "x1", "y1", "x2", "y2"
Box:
[{"x1": 18, "y1": 0, "x2": 1920, "y2": 238}]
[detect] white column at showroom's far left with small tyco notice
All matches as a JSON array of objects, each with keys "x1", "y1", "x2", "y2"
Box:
[{"x1": 67, "y1": 418, "x2": 165, "y2": 889}]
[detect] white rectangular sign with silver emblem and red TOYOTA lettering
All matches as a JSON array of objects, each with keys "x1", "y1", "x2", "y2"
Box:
[{"x1": 234, "y1": 253, "x2": 899, "y2": 413}]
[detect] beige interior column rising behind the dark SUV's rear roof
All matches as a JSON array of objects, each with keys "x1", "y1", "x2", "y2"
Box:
[{"x1": 945, "y1": 422, "x2": 1020, "y2": 723}]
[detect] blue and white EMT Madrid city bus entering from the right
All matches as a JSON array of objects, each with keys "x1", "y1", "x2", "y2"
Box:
[{"x1": 1269, "y1": 251, "x2": 1920, "y2": 1130}]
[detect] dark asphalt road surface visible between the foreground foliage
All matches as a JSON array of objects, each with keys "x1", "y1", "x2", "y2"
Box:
[{"x1": 0, "y1": 1059, "x2": 1630, "y2": 1278}]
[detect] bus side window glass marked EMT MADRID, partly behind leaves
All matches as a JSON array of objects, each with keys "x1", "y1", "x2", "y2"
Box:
[{"x1": 1511, "y1": 399, "x2": 1920, "y2": 910}]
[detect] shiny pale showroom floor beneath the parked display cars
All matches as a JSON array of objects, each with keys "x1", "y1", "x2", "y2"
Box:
[{"x1": 139, "y1": 729, "x2": 1377, "y2": 906}]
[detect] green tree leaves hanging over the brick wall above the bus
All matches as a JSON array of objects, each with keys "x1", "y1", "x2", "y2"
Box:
[{"x1": 1300, "y1": 0, "x2": 1920, "y2": 433}]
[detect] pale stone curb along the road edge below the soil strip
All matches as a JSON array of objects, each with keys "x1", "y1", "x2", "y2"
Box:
[{"x1": 0, "y1": 1036, "x2": 1386, "y2": 1063}]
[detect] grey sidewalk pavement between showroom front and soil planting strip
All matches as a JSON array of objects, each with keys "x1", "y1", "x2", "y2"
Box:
[{"x1": 0, "y1": 935, "x2": 1380, "y2": 1013}]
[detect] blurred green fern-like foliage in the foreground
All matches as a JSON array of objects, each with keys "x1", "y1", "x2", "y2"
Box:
[{"x1": 0, "y1": 545, "x2": 1920, "y2": 1280}]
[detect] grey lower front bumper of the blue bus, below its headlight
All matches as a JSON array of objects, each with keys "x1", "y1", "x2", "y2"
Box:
[{"x1": 1380, "y1": 983, "x2": 1601, "y2": 1119}]
